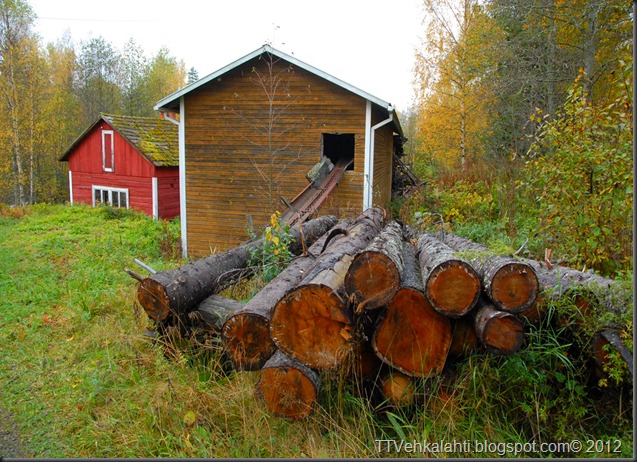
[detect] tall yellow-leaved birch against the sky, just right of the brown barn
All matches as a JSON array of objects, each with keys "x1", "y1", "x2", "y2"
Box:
[{"x1": 416, "y1": 0, "x2": 501, "y2": 171}]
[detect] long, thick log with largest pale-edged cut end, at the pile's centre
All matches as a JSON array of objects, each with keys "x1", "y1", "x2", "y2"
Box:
[{"x1": 270, "y1": 208, "x2": 385, "y2": 369}]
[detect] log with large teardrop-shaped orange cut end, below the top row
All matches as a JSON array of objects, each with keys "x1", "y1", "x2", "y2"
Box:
[{"x1": 372, "y1": 242, "x2": 452, "y2": 377}]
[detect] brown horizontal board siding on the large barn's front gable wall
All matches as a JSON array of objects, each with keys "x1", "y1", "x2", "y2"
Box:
[{"x1": 185, "y1": 56, "x2": 366, "y2": 256}]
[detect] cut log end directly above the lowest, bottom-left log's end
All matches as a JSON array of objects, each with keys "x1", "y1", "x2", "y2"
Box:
[{"x1": 221, "y1": 313, "x2": 276, "y2": 371}]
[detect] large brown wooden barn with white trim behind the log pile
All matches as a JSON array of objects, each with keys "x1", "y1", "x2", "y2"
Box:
[{"x1": 155, "y1": 45, "x2": 403, "y2": 256}]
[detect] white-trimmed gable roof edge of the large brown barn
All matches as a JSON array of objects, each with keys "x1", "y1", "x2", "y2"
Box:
[{"x1": 155, "y1": 44, "x2": 401, "y2": 135}]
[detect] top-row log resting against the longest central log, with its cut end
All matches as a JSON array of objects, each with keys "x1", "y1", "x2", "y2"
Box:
[{"x1": 345, "y1": 221, "x2": 403, "y2": 312}]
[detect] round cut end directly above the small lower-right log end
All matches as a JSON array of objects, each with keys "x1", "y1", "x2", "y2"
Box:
[{"x1": 489, "y1": 263, "x2": 539, "y2": 313}]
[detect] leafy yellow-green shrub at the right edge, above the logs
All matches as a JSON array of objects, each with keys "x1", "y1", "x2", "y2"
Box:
[{"x1": 521, "y1": 70, "x2": 633, "y2": 275}]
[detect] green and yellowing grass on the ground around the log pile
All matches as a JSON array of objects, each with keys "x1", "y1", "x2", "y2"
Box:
[{"x1": 0, "y1": 205, "x2": 633, "y2": 458}]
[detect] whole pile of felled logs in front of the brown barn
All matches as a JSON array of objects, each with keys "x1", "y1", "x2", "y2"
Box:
[{"x1": 130, "y1": 208, "x2": 632, "y2": 420}]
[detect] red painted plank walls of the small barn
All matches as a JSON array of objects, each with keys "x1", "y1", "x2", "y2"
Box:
[{"x1": 68, "y1": 121, "x2": 179, "y2": 219}]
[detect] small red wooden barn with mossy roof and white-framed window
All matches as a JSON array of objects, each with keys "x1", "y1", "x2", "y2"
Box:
[{"x1": 60, "y1": 114, "x2": 180, "y2": 219}]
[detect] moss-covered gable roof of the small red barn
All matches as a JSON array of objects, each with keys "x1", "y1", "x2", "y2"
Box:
[{"x1": 60, "y1": 113, "x2": 179, "y2": 167}]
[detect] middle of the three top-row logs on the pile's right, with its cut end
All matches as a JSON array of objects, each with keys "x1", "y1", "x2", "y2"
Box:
[{"x1": 418, "y1": 234, "x2": 482, "y2": 318}]
